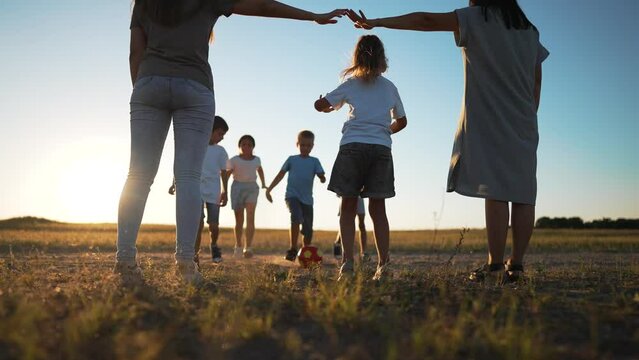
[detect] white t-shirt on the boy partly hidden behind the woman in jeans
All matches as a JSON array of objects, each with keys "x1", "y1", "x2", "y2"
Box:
[{"x1": 200, "y1": 144, "x2": 229, "y2": 204}]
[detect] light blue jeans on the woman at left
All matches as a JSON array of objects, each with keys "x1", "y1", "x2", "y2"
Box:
[{"x1": 116, "y1": 76, "x2": 215, "y2": 262}]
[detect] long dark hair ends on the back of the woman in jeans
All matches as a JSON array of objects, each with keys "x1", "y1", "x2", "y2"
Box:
[{"x1": 133, "y1": 0, "x2": 205, "y2": 27}]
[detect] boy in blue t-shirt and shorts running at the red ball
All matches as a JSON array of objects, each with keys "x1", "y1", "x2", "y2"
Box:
[{"x1": 266, "y1": 130, "x2": 326, "y2": 261}]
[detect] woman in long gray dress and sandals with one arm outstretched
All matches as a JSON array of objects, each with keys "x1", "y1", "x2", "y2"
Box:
[{"x1": 348, "y1": 0, "x2": 548, "y2": 281}]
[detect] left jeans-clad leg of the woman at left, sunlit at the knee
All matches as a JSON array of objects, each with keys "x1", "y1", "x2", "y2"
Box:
[{"x1": 116, "y1": 79, "x2": 171, "y2": 262}]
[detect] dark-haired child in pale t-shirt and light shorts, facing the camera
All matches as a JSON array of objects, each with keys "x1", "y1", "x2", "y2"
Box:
[{"x1": 226, "y1": 135, "x2": 266, "y2": 258}]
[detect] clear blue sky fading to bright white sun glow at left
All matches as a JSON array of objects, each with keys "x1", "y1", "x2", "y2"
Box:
[{"x1": 0, "y1": 0, "x2": 639, "y2": 229}]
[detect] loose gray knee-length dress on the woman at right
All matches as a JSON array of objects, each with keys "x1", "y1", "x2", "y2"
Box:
[{"x1": 447, "y1": 6, "x2": 549, "y2": 205}]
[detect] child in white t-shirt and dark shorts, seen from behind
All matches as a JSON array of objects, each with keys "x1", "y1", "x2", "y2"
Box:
[{"x1": 315, "y1": 35, "x2": 407, "y2": 280}]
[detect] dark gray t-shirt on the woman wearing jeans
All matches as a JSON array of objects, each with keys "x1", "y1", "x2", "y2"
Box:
[{"x1": 130, "y1": 0, "x2": 235, "y2": 90}]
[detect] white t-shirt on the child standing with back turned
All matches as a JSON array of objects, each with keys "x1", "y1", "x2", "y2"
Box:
[{"x1": 326, "y1": 76, "x2": 406, "y2": 148}]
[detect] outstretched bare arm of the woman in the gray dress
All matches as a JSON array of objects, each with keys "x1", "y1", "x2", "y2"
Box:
[{"x1": 346, "y1": 10, "x2": 459, "y2": 32}]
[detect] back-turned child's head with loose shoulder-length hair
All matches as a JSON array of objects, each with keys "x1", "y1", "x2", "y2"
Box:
[{"x1": 342, "y1": 35, "x2": 388, "y2": 82}]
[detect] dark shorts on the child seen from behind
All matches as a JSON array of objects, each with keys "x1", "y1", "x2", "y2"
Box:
[{"x1": 328, "y1": 143, "x2": 395, "y2": 199}]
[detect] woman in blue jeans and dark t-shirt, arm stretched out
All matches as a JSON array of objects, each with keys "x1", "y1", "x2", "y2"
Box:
[{"x1": 114, "y1": 0, "x2": 345, "y2": 283}]
